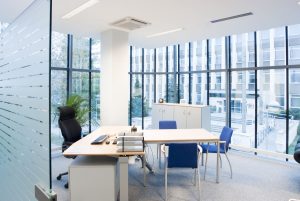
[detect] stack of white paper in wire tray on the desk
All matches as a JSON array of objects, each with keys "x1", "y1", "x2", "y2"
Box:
[{"x1": 117, "y1": 132, "x2": 144, "y2": 152}]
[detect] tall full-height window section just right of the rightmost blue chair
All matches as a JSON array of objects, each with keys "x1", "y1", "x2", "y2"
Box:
[{"x1": 230, "y1": 32, "x2": 256, "y2": 148}]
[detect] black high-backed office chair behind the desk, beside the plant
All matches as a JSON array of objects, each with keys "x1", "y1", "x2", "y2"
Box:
[{"x1": 56, "y1": 106, "x2": 81, "y2": 188}]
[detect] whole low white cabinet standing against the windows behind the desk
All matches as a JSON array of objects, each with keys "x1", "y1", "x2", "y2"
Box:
[{"x1": 152, "y1": 103, "x2": 210, "y2": 130}]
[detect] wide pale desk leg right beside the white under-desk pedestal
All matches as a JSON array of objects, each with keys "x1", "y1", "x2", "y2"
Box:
[{"x1": 119, "y1": 157, "x2": 128, "y2": 201}]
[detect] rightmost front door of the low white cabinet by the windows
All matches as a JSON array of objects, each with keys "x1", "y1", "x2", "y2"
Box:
[{"x1": 186, "y1": 107, "x2": 202, "y2": 128}]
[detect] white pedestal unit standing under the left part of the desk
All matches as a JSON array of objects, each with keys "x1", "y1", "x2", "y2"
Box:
[{"x1": 69, "y1": 156, "x2": 120, "y2": 201}]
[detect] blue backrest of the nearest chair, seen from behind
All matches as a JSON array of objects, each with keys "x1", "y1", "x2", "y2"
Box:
[{"x1": 168, "y1": 143, "x2": 198, "y2": 168}]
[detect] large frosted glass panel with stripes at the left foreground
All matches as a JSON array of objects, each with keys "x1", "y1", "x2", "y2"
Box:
[{"x1": 0, "y1": 0, "x2": 50, "y2": 201}]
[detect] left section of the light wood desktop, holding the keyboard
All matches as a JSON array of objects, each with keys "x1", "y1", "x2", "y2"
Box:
[{"x1": 63, "y1": 126, "x2": 145, "y2": 157}]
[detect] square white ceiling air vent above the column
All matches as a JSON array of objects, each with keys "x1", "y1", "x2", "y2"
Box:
[{"x1": 111, "y1": 17, "x2": 150, "y2": 31}]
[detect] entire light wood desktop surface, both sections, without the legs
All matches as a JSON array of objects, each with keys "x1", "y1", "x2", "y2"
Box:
[{"x1": 63, "y1": 126, "x2": 219, "y2": 157}]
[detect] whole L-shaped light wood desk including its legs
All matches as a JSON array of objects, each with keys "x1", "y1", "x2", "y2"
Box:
[{"x1": 63, "y1": 126, "x2": 220, "y2": 201}]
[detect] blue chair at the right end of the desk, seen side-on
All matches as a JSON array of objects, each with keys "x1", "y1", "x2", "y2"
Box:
[{"x1": 201, "y1": 126, "x2": 233, "y2": 179}]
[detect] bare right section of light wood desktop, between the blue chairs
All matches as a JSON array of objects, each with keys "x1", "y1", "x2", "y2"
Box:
[{"x1": 143, "y1": 129, "x2": 219, "y2": 143}]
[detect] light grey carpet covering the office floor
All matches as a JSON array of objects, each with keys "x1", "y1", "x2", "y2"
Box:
[{"x1": 52, "y1": 147, "x2": 300, "y2": 201}]
